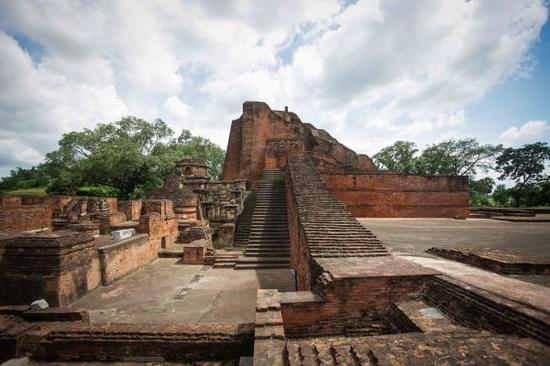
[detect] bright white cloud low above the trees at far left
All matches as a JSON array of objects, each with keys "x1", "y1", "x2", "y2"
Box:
[{"x1": 0, "y1": 32, "x2": 128, "y2": 174}]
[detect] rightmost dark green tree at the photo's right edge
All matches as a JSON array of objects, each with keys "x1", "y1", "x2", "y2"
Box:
[{"x1": 496, "y1": 142, "x2": 550, "y2": 207}]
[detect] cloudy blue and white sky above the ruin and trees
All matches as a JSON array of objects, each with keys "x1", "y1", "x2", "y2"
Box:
[{"x1": 0, "y1": 0, "x2": 550, "y2": 176}]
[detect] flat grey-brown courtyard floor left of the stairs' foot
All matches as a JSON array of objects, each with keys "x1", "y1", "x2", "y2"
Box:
[{"x1": 69, "y1": 258, "x2": 294, "y2": 324}]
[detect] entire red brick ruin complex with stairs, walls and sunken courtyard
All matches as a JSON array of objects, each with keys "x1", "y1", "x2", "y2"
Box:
[{"x1": 0, "y1": 102, "x2": 550, "y2": 365}]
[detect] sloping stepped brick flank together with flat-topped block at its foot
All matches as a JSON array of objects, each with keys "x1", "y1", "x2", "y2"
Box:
[{"x1": 281, "y1": 157, "x2": 440, "y2": 335}]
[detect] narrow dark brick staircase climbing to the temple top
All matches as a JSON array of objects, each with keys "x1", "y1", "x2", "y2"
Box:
[{"x1": 235, "y1": 170, "x2": 290, "y2": 269}]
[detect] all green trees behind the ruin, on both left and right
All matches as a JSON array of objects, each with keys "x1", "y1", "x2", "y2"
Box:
[{"x1": 0, "y1": 117, "x2": 550, "y2": 206}]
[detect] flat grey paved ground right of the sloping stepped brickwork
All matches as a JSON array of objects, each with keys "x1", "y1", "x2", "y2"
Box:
[{"x1": 359, "y1": 218, "x2": 550, "y2": 287}]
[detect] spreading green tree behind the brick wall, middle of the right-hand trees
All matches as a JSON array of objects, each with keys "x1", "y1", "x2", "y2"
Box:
[{"x1": 416, "y1": 139, "x2": 502, "y2": 176}]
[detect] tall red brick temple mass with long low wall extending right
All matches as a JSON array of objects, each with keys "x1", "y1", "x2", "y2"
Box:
[{"x1": 224, "y1": 102, "x2": 469, "y2": 217}]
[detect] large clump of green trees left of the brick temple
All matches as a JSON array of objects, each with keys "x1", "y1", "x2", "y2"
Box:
[{"x1": 0, "y1": 117, "x2": 225, "y2": 199}]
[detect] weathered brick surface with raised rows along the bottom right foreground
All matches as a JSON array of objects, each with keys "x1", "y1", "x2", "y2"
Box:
[{"x1": 283, "y1": 333, "x2": 550, "y2": 366}]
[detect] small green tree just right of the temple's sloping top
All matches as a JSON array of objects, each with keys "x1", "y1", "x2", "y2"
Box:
[{"x1": 372, "y1": 141, "x2": 418, "y2": 173}]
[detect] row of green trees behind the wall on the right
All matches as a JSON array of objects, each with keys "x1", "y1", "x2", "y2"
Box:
[{"x1": 373, "y1": 139, "x2": 550, "y2": 207}]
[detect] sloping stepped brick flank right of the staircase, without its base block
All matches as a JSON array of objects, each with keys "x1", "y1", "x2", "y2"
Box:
[{"x1": 287, "y1": 157, "x2": 389, "y2": 290}]
